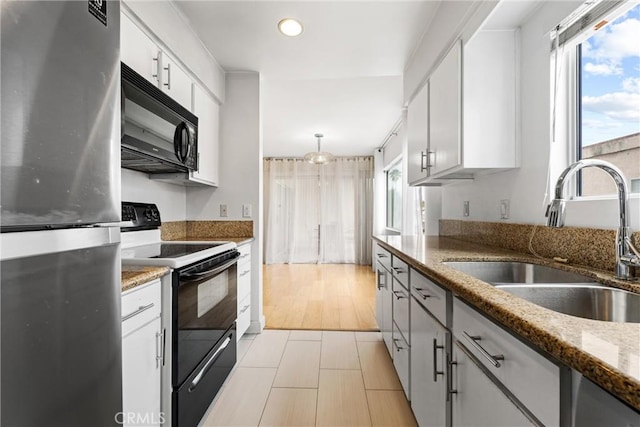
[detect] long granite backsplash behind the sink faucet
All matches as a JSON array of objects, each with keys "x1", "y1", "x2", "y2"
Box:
[{"x1": 440, "y1": 219, "x2": 640, "y2": 271}]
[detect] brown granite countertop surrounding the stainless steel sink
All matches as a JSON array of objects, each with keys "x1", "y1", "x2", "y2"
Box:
[{"x1": 374, "y1": 236, "x2": 640, "y2": 410}]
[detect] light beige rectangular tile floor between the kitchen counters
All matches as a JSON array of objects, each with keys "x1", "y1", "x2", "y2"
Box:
[{"x1": 201, "y1": 330, "x2": 416, "y2": 427}]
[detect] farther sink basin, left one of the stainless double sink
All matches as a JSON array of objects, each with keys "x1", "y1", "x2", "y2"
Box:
[{"x1": 444, "y1": 261, "x2": 596, "y2": 285}]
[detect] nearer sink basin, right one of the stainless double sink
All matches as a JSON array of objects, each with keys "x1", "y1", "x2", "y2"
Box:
[{"x1": 496, "y1": 284, "x2": 640, "y2": 323}]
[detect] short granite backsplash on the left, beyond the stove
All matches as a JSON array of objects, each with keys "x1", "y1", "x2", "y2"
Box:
[{"x1": 161, "y1": 221, "x2": 253, "y2": 240}]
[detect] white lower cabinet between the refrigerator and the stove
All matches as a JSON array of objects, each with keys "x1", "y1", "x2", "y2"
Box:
[{"x1": 122, "y1": 280, "x2": 166, "y2": 426}]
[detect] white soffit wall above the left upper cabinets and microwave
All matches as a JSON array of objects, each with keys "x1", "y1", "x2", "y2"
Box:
[{"x1": 123, "y1": 0, "x2": 225, "y2": 104}]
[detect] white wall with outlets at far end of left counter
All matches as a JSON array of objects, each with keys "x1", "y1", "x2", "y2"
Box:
[{"x1": 187, "y1": 72, "x2": 264, "y2": 333}]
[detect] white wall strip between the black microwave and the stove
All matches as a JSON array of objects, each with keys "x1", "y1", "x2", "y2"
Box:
[{"x1": 120, "y1": 169, "x2": 187, "y2": 222}]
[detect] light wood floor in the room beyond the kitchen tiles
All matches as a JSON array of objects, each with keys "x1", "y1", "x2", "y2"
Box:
[{"x1": 263, "y1": 264, "x2": 378, "y2": 331}]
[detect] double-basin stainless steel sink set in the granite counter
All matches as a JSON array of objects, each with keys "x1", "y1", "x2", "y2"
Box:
[{"x1": 444, "y1": 261, "x2": 640, "y2": 323}]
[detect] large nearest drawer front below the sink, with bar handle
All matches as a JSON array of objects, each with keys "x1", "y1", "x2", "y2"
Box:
[{"x1": 453, "y1": 297, "x2": 560, "y2": 426}]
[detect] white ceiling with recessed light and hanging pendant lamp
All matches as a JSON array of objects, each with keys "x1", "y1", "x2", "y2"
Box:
[{"x1": 176, "y1": 0, "x2": 439, "y2": 157}]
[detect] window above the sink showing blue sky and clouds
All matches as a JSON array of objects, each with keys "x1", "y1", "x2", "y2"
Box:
[{"x1": 560, "y1": 4, "x2": 640, "y2": 196}]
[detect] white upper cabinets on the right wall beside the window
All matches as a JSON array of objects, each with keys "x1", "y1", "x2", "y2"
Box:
[{"x1": 408, "y1": 30, "x2": 519, "y2": 185}]
